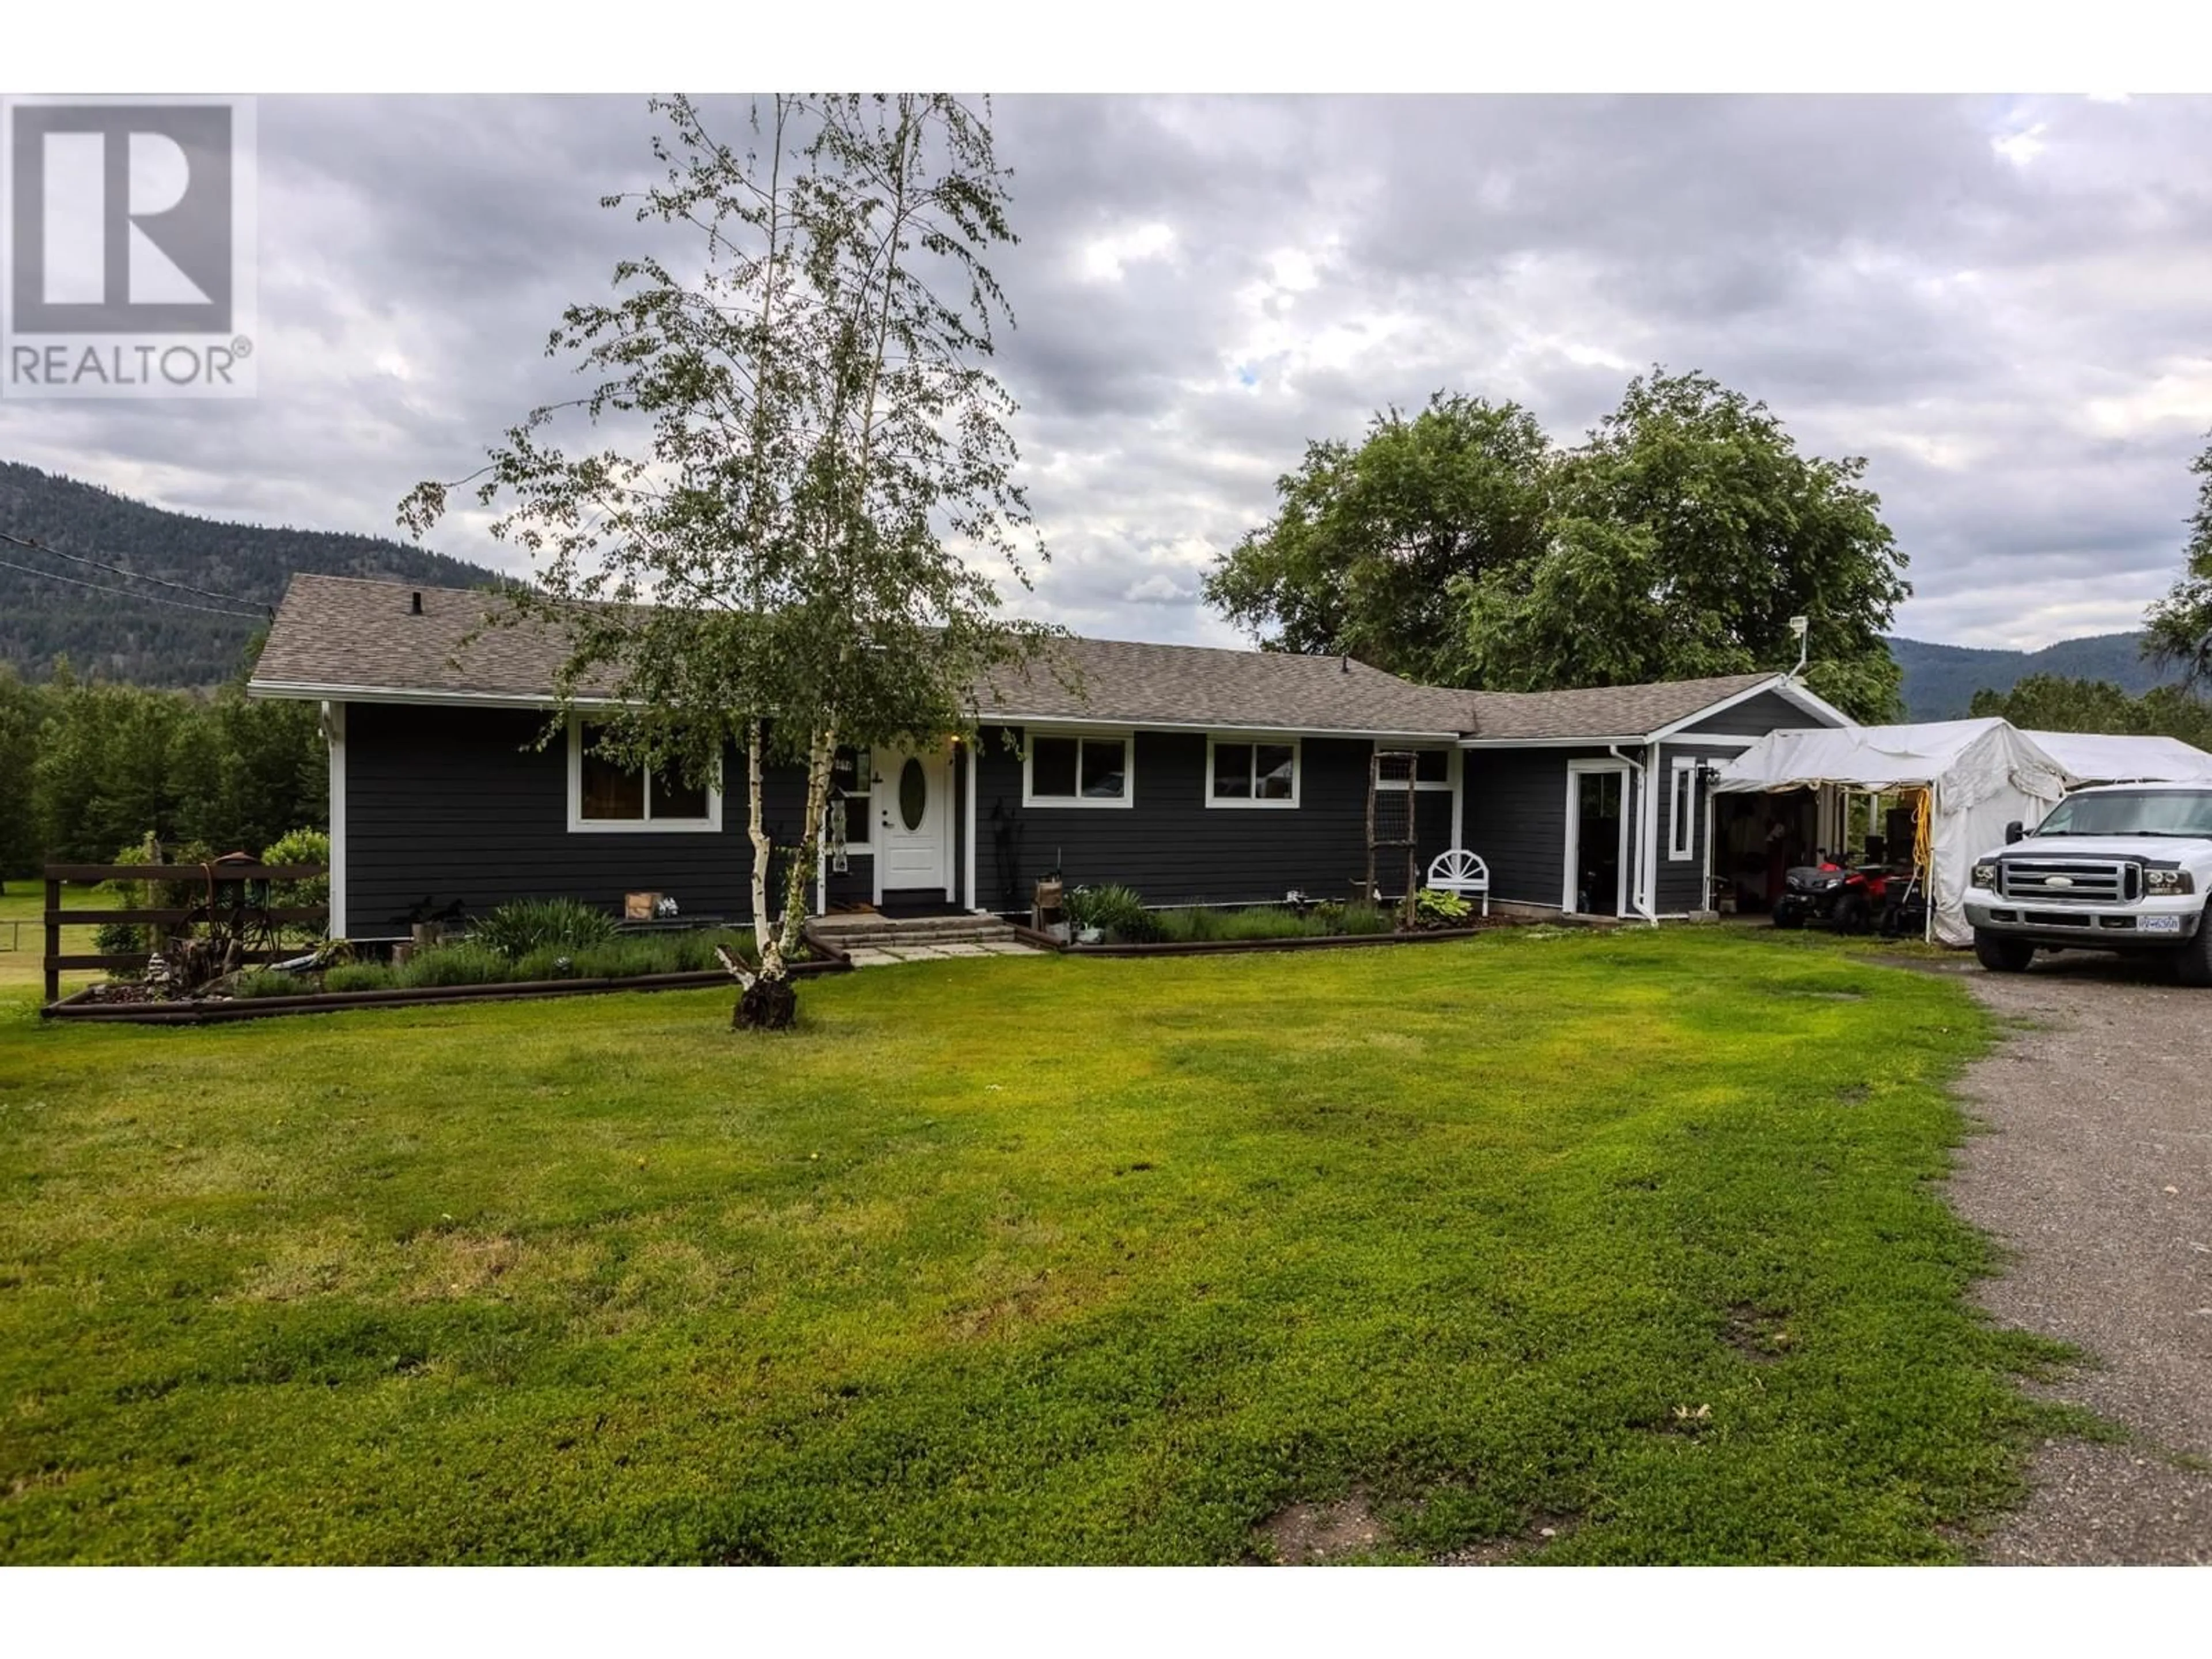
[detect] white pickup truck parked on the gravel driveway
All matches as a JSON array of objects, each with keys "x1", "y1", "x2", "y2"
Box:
[{"x1": 1967, "y1": 783, "x2": 2212, "y2": 984}]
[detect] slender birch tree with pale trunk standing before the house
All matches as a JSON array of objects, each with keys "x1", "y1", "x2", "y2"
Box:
[{"x1": 400, "y1": 95, "x2": 1051, "y2": 1027}]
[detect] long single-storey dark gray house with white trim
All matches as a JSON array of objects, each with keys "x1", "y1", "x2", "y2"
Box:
[{"x1": 250, "y1": 575, "x2": 1845, "y2": 940}]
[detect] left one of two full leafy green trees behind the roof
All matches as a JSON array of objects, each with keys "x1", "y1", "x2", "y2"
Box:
[{"x1": 1206, "y1": 392, "x2": 1555, "y2": 684}]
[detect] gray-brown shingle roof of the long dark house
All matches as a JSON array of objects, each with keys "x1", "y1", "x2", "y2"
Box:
[{"x1": 252, "y1": 575, "x2": 1772, "y2": 739}]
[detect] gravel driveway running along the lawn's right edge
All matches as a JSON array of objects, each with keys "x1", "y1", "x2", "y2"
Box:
[{"x1": 1942, "y1": 953, "x2": 2212, "y2": 1564}]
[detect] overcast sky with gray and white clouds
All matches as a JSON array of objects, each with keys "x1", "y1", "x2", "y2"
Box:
[{"x1": 0, "y1": 97, "x2": 2212, "y2": 646}]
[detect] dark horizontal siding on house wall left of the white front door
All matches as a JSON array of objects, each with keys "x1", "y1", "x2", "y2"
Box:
[{"x1": 345, "y1": 703, "x2": 874, "y2": 938}]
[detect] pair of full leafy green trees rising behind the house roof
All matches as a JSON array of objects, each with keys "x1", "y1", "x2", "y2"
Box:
[{"x1": 1206, "y1": 369, "x2": 1911, "y2": 719}]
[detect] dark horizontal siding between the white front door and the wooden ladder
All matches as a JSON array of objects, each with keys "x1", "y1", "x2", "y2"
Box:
[{"x1": 975, "y1": 728, "x2": 1451, "y2": 909}]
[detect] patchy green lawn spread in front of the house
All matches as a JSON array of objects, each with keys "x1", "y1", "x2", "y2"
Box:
[{"x1": 0, "y1": 929, "x2": 2048, "y2": 1562}]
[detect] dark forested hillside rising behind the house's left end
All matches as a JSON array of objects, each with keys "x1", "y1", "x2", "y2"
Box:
[{"x1": 0, "y1": 463, "x2": 493, "y2": 688}]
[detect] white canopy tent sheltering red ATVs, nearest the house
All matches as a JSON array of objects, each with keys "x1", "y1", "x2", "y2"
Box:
[{"x1": 1712, "y1": 719, "x2": 2070, "y2": 945}]
